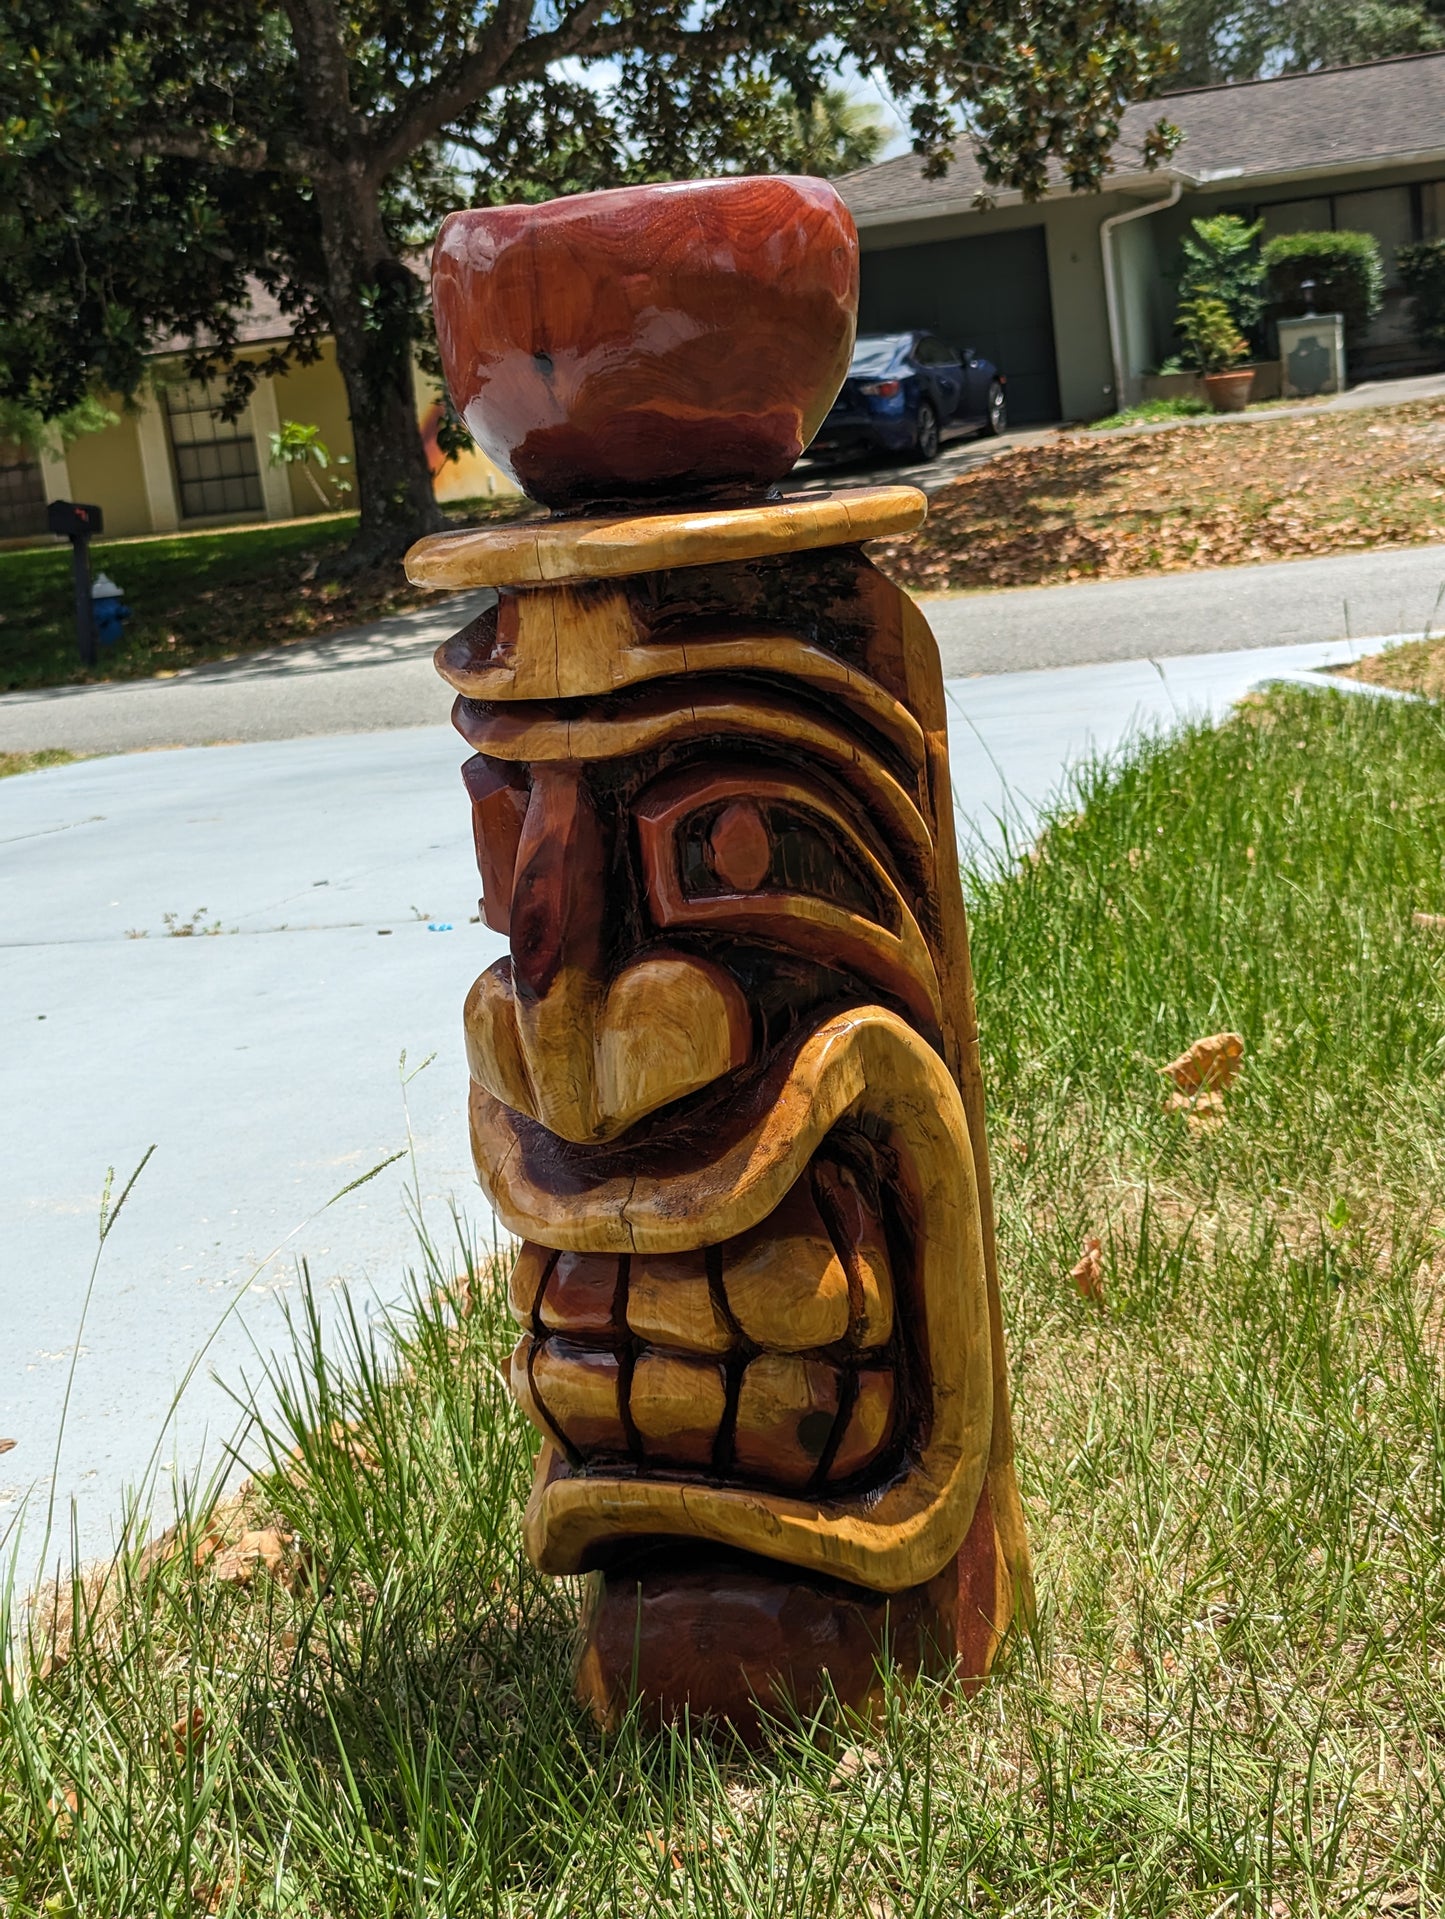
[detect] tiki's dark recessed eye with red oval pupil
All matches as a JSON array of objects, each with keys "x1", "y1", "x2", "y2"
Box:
[{"x1": 677, "y1": 798, "x2": 896, "y2": 927}]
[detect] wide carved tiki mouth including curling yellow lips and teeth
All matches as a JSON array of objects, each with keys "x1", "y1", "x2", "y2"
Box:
[{"x1": 472, "y1": 1006, "x2": 992, "y2": 1593}]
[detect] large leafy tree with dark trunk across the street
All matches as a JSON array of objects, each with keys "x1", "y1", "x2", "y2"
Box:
[{"x1": 0, "y1": 0, "x2": 1171, "y2": 557}]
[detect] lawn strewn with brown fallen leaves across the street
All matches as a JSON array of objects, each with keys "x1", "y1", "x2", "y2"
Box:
[{"x1": 879, "y1": 399, "x2": 1445, "y2": 593}]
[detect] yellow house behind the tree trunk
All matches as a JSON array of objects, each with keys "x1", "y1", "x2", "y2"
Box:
[{"x1": 0, "y1": 284, "x2": 516, "y2": 543}]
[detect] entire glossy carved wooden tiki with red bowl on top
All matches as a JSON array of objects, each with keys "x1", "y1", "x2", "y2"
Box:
[{"x1": 407, "y1": 178, "x2": 1030, "y2": 1731}]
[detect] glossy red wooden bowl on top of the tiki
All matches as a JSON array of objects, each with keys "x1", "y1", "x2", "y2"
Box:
[{"x1": 432, "y1": 177, "x2": 858, "y2": 510}]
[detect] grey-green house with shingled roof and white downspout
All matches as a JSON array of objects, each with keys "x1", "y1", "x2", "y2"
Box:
[{"x1": 837, "y1": 54, "x2": 1445, "y2": 424}]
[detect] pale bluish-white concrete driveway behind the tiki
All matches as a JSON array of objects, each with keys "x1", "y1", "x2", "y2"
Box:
[{"x1": 0, "y1": 643, "x2": 1349, "y2": 1562}]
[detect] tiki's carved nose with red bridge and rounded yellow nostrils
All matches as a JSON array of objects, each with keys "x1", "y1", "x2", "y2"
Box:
[{"x1": 466, "y1": 764, "x2": 752, "y2": 1144}]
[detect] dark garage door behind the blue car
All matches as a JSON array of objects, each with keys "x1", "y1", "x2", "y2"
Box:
[{"x1": 858, "y1": 226, "x2": 1059, "y2": 426}]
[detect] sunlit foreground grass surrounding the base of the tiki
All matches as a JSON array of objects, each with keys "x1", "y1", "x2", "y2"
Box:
[{"x1": 0, "y1": 689, "x2": 1445, "y2": 1919}]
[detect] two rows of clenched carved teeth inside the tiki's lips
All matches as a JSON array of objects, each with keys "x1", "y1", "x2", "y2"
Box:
[{"x1": 509, "y1": 1132, "x2": 917, "y2": 1497}]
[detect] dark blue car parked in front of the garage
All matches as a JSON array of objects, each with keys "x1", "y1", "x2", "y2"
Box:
[{"x1": 808, "y1": 332, "x2": 1009, "y2": 461}]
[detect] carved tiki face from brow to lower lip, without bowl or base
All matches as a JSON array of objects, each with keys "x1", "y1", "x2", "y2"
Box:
[{"x1": 439, "y1": 547, "x2": 1021, "y2": 1696}]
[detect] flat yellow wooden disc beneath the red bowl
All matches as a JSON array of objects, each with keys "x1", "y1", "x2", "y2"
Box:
[{"x1": 407, "y1": 486, "x2": 927, "y2": 591}]
